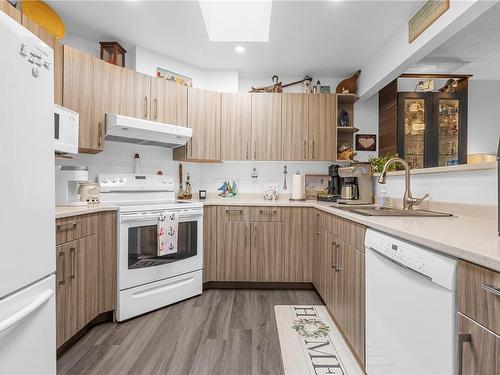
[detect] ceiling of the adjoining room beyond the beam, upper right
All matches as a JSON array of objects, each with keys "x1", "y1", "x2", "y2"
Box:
[{"x1": 411, "y1": 4, "x2": 500, "y2": 80}]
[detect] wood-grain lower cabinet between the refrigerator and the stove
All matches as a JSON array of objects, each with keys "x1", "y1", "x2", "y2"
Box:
[{"x1": 56, "y1": 212, "x2": 116, "y2": 348}]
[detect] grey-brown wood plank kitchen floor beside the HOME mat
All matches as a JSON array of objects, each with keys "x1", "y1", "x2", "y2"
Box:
[{"x1": 57, "y1": 289, "x2": 321, "y2": 375}]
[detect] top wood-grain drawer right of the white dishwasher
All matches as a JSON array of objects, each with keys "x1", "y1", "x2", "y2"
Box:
[{"x1": 457, "y1": 261, "x2": 500, "y2": 334}]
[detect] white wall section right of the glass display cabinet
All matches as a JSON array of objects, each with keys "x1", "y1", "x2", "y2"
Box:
[{"x1": 467, "y1": 79, "x2": 500, "y2": 155}]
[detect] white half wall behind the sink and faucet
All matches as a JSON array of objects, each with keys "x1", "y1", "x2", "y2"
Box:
[{"x1": 374, "y1": 169, "x2": 498, "y2": 206}]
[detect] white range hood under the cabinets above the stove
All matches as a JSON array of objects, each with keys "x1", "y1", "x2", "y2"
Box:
[{"x1": 105, "y1": 113, "x2": 193, "y2": 148}]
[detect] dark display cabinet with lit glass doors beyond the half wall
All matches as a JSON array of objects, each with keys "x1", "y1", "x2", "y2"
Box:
[{"x1": 397, "y1": 92, "x2": 467, "y2": 168}]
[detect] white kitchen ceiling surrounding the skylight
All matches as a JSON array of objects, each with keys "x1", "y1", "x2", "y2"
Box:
[{"x1": 48, "y1": 0, "x2": 423, "y2": 77}]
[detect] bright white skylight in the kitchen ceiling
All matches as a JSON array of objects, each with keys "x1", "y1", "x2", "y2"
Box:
[{"x1": 199, "y1": 0, "x2": 273, "y2": 42}]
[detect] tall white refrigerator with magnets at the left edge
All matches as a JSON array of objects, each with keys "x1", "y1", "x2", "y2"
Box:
[{"x1": 0, "y1": 12, "x2": 56, "y2": 375}]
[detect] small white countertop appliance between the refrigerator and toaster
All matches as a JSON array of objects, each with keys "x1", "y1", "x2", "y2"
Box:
[{"x1": 55, "y1": 165, "x2": 89, "y2": 206}]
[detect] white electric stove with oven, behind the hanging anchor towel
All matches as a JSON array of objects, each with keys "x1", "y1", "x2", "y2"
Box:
[{"x1": 98, "y1": 174, "x2": 203, "y2": 321}]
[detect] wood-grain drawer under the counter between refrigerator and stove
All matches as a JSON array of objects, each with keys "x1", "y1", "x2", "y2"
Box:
[{"x1": 56, "y1": 214, "x2": 99, "y2": 245}]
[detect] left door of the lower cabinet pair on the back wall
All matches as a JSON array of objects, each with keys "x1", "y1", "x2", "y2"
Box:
[{"x1": 217, "y1": 222, "x2": 251, "y2": 281}]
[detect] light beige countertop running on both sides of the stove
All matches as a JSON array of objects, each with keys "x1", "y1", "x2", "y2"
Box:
[{"x1": 56, "y1": 200, "x2": 500, "y2": 272}]
